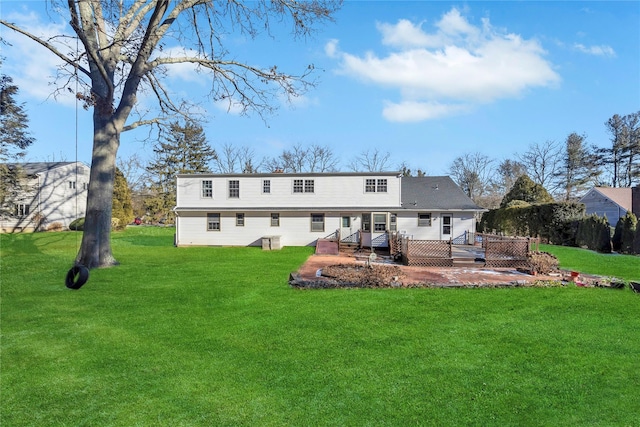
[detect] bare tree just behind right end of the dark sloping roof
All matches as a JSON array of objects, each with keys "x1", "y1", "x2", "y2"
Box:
[{"x1": 449, "y1": 153, "x2": 495, "y2": 206}]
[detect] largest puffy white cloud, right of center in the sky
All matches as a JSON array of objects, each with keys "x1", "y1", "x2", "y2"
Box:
[{"x1": 330, "y1": 8, "x2": 560, "y2": 121}]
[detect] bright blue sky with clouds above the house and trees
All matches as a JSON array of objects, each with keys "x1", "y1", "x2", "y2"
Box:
[{"x1": 0, "y1": 0, "x2": 640, "y2": 175}]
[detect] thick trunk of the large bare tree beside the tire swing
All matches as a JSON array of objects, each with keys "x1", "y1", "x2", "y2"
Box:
[{"x1": 76, "y1": 112, "x2": 120, "y2": 268}]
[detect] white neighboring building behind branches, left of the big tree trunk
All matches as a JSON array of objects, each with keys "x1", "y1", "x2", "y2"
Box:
[{"x1": 0, "y1": 162, "x2": 90, "y2": 232}]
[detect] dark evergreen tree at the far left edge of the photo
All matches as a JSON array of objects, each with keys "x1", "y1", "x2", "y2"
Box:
[{"x1": 0, "y1": 73, "x2": 33, "y2": 215}]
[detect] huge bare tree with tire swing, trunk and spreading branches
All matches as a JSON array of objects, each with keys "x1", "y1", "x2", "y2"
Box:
[{"x1": 0, "y1": 0, "x2": 341, "y2": 268}]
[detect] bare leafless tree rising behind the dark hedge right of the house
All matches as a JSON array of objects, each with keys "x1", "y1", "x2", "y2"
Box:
[{"x1": 517, "y1": 140, "x2": 563, "y2": 196}]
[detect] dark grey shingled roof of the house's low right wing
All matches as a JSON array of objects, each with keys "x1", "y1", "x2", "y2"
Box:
[{"x1": 401, "y1": 176, "x2": 485, "y2": 211}]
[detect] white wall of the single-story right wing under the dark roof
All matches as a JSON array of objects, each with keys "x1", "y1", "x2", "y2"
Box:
[{"x1": 398, "y1": 211, "x2": 476, "y2": 240}]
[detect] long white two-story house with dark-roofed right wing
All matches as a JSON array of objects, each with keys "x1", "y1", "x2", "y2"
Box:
[{"x1": 175, "y1": 172, "x2": 483, "y2": 247}]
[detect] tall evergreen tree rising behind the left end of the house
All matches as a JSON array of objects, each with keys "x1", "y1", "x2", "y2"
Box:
[{"x1": 145, "y1": 122, "x2": 217, "y2": 220}]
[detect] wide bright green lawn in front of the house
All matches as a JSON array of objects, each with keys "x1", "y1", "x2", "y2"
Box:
[{"x1": 0, "y1": 231, "x2": 640, "y2": 427}]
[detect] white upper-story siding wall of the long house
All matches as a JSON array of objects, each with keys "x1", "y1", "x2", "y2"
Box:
[{"x1": 177, "y1": 174, "x2": 400, "y2": 209}]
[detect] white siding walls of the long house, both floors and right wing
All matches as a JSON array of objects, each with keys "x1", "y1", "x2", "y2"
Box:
[{"x1": 176, "y1": 173, "x2": 475, "y2": 246}]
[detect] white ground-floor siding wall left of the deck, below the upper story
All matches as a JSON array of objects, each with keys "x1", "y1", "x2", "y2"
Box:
[{"x1": 176, "y1": 208, "x2": 341, "y2": 246}]
